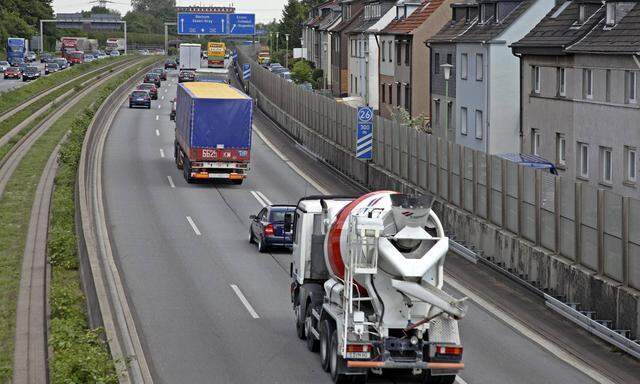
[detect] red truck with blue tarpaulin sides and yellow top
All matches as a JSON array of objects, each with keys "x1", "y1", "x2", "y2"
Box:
[{"x1": 174, "y1": 83, "x2": 253, "y2": 184}]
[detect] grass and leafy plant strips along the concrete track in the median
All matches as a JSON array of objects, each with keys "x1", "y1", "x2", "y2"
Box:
[{"x1": 0, "y1": 59, "x2": 158, "y2": 383}]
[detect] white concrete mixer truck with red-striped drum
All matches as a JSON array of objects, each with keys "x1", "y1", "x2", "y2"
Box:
[{"x1": 285, "y1": 191, "x2": 466, "y2": 384}]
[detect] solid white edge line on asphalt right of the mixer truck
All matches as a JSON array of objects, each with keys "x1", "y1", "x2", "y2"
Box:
[{"x1": 445, "y1": 274, "x2": 614, "y2": 384}]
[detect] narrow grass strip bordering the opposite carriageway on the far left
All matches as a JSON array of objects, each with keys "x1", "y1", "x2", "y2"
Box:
[{"x1": 0, "y1": 56, "x2": 129, "y2": 113}]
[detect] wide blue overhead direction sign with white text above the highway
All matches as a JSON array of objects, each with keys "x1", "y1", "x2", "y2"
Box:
[{"x1": 178, "y1": 13, "x2": 256, "y2": 36}]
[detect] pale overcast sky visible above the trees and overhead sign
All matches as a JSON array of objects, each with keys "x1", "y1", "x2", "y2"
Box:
[{"x1": 53, "y1": 0, "x2": 286, "y2": 22}]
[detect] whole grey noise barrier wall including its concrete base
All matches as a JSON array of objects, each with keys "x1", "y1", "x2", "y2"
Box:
[{"x1": 238, "y1": 47, "x2": 640, "y2": 344}]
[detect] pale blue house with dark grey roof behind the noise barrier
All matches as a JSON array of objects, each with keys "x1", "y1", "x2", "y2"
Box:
[{"x1": 429, "y1": 0, "x2": 555, "y2": 154}]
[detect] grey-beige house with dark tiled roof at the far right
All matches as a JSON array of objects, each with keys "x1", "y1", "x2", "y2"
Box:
[{"x1": 513, "y1": 0, "x2": 640, "y2": 198}]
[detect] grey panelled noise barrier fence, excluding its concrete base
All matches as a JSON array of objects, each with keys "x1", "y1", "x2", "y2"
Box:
[{"x1": 239, "y1": 51, "x2": 640, "y2": 289}]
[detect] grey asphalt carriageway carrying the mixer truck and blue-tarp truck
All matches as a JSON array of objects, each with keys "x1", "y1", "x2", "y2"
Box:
[{"x1": 103, "y1": 72, "x2": 628, "y2": 384}]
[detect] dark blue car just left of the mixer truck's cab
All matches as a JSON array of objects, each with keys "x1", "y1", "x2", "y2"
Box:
[{"x1": 249, "y1": 205, "x2": 296, "y2": 253}]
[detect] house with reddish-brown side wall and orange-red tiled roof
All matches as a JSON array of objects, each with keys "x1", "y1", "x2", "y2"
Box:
[{"x1": 380, "y1": 0, "x2": 451, "y2": 117}]
